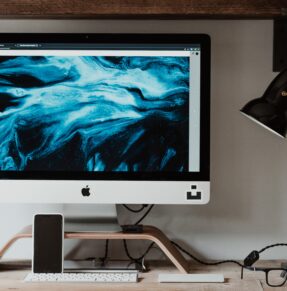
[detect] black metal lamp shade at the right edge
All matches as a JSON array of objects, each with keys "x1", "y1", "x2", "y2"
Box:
[{"x1": 240, "y1": 69, "x2": 287, "y2": 138}]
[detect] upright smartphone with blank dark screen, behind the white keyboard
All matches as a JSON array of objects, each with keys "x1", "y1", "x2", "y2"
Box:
[{"x1": 32, "y1": 214, "x2": 64, "y2": 273}]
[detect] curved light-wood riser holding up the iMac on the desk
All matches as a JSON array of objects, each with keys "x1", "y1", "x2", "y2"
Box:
[{"x1": 0, "y1": 225, "x2": 192, "y2": 274}]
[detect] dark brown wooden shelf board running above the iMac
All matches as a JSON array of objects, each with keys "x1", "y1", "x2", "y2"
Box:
[{"x1": 0, "y1": 0, "x2": 287, "y2": 19}]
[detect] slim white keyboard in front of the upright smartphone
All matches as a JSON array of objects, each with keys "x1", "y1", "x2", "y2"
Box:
[{"x1": 24, "y1": 270, "x2": 138, "y2": 283}]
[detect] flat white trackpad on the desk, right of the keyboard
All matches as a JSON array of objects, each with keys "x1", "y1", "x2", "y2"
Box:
[{"x1": 158, "y1": 273, "x2": 224, "y2": 283}]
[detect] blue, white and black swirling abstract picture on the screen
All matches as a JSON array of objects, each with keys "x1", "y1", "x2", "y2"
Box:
[{"x1": 0, "y1": 56, "x2": 190, "y2": 172}]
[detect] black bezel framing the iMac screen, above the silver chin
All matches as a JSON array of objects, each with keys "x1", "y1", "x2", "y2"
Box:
[{"x1": 0, "y1": 33, "x2": 210, "y2": 181}]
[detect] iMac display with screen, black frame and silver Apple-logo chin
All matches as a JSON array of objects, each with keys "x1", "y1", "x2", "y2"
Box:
[{"x1": 0, "y1": 34, "x2": 210, "y2": 204}]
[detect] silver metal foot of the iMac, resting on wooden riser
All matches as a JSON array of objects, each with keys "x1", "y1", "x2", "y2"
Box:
[{"x1": 63, "y1": 204, "x2": 122, "y2": 232}]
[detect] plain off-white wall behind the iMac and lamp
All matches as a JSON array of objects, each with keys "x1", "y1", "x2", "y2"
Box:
[{"x1": 0, "y1": 20, "x2": 287, "y2": 259}]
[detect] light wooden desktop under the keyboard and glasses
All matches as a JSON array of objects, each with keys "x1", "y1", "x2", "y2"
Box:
[{"x1": 0, "y1": 261, "x2": 287, "y2": 291}]
